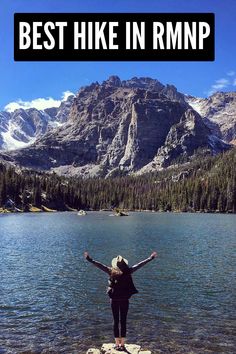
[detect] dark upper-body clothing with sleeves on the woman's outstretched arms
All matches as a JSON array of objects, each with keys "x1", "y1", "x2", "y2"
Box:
[{"x1": 86, "y1": 257, "x2": 154, "y2": 300}]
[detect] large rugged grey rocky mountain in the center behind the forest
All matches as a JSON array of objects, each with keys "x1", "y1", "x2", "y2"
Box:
[{"x1": 1, "y1": 76, "x2": 234, "y2": 177}]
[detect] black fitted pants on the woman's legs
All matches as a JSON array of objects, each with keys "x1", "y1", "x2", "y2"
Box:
[{"x1": 111, "y1": 299, "x2": 129, "y2": 338}]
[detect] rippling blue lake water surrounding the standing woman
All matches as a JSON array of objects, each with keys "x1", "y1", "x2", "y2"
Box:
[{"x1": 0, "y1": 212, "x2": 236, "y2": 354}]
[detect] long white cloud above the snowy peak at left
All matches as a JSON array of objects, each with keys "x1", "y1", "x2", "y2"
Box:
[{"x1": 4, "y1": 91, "x2": 74, "y2": 112}]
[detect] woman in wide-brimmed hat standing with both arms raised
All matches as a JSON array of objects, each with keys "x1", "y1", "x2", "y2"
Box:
[{"x1": 84, "y1": 252, "x2": 157, "y2": 351}]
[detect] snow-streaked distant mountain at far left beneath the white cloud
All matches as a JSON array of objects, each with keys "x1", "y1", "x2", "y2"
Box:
[{"x1": 0, "y1": 96, "x2": 73, "y2": 150}]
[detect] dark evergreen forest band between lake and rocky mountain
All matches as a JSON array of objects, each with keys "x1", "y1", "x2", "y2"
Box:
[{"x1": 0, "y1": 149, "x2": 236, "y2": 213}]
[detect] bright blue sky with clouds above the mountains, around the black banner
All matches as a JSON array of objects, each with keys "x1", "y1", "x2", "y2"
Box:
[{"x1": 0, "y1": 0, "x2": 236, "y2": 111}]
